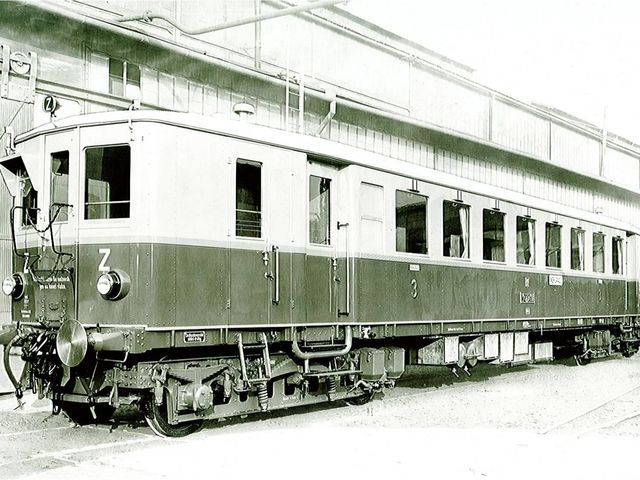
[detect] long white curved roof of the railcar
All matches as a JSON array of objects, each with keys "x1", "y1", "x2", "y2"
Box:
[{"x1": 16, "y1": 110, "x2": 640, "y2": 233}]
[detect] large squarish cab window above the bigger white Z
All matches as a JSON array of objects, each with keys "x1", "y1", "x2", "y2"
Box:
[{"x1": 84, "y1": 145, "x2": 131, "y2": 220}]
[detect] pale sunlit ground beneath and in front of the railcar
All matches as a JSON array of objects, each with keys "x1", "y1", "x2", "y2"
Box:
[{"x1": 0, "y1": 356, "x2": 640, "y2": 480}]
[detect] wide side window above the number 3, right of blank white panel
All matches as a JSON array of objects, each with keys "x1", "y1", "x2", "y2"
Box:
[{"x1": 396, "y1": 190, "x2": 429, "y2": 254}]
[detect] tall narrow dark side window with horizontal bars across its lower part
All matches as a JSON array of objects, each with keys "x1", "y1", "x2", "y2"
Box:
[{"x1": 236, "y1": 160, "x2": 262, "y2": 238}]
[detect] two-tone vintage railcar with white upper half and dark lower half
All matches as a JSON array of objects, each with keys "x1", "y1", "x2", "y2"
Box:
[{"x1": 0, "y1": 110, "x2": 638, "y2": 436}]
